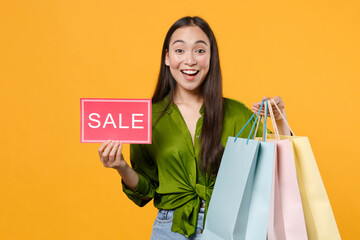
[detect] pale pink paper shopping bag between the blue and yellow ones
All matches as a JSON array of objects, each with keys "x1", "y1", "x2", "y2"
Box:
[{"x1": 262, "y1": 102, "x2": 308, "y2": 240}]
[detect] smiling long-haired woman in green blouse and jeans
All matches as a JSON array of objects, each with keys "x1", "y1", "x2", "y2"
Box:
[{"x1": 98, "y1": 17, "x2": 288, "y2": 240}]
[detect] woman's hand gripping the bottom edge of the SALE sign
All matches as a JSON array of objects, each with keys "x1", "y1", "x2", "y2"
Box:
[{"x1": 98, "y1": 140, "x2": 129, "y2": 172}]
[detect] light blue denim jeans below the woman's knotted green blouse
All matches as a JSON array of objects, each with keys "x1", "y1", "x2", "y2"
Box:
[{"x1": 150, "y1": 202, "x2": 205, "y2": 240}]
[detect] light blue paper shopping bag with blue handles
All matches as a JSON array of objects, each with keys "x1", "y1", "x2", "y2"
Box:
[{"x1": 201, "y1": 99, "x2": 276, "y2": 240}]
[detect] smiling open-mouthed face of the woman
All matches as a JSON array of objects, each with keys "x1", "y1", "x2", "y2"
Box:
[{"x1": 165, "y1": 26, "x2": 211, "y2": 92}]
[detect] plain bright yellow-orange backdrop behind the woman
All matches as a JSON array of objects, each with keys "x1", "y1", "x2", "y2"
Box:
[{"x1": 0, "y1": 0, "x2": 360, "y2": 239}]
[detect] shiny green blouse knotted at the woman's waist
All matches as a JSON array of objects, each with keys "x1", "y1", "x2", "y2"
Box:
[{"x1": 122, "y1": 97, "x2": 262, "y2": 237}]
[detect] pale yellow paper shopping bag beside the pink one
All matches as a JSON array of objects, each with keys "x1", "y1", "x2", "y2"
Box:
[{"x1": 268, "y1": 98, "x2": 341, "y2": 240}]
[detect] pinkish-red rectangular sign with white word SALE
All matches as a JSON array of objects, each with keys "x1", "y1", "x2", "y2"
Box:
[{"x1": 80, "y1": 98, "x2": 151, "y2": 144}]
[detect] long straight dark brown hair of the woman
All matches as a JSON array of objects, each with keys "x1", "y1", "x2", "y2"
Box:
[{"x1": 152, "y1": 17, "x2": 224, "y2": 176}]
